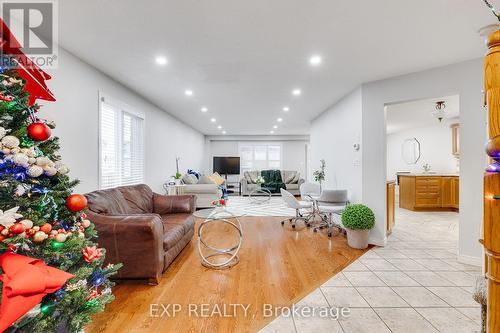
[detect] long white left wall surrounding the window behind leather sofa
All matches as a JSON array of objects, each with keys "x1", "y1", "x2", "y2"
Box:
[{"x1": 36, "y1": 49, "x2": 204, "y2": 193}]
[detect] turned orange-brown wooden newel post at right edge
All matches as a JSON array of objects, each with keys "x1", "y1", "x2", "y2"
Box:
[{"x1": 482, "y1": 30, "x2": 500, "y2": 333}]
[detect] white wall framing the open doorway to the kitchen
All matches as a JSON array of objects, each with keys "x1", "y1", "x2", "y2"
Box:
[{"x1": 362, "y1": 59, "x2": 487, "y2": 262}]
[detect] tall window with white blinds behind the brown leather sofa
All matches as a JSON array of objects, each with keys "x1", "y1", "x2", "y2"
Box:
[{"x1": 99, "y1": 97, "x2": 144, "y2": 189}]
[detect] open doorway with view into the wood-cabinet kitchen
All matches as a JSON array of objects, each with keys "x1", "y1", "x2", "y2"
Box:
[{"x1": 385, "y1": 95, "x2": 460, "y2": 235}]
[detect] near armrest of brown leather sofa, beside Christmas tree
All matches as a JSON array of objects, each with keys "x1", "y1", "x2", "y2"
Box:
[{"x1": 87, "y1": 211, "x2": 164, "y2": 281}]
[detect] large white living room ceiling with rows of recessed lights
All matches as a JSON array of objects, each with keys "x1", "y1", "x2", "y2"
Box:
[{"x1": 59, "y1": 0, "x2": 496, "y2": 135}]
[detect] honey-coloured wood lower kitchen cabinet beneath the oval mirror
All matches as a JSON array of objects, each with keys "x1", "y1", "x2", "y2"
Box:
[{"x1": 399, "y1": 175, "x2": 459, "y2": 211}]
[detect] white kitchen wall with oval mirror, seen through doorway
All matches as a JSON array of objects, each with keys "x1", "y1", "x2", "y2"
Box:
[{"x1": 387, "y1": 119, "x2": 458, "y2": 180}]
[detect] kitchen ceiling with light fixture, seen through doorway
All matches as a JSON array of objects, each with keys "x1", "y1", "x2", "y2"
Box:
[{"x1": 386, "y1": 95, "x2": 460, "y2": 134}]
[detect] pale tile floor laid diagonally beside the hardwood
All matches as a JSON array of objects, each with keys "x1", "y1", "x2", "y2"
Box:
[{"x1": 260, "y1": 210, "x2": 481, "y2": 333}]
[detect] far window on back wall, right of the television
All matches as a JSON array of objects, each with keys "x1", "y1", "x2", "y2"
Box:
[{"x1": 239, "y1": 143, "x2": 281, "y2": 173}]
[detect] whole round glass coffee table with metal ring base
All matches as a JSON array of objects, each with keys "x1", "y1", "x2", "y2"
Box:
[{"x1": 193, "y1": 207, "x2": 244, "y2": 269}]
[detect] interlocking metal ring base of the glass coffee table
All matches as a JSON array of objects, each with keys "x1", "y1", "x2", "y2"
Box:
[{"x1": 198, "y1": 212, "x2": 243, "y2": 269}]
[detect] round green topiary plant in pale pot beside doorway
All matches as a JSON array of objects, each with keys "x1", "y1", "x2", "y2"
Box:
[{"x1": 342, "y1": 204, "x2": 375, "y2": 249}]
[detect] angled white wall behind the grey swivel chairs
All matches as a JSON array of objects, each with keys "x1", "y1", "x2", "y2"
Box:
[{"x1": 311, "y1": 88, "x2": 363, "y2": 202}]
